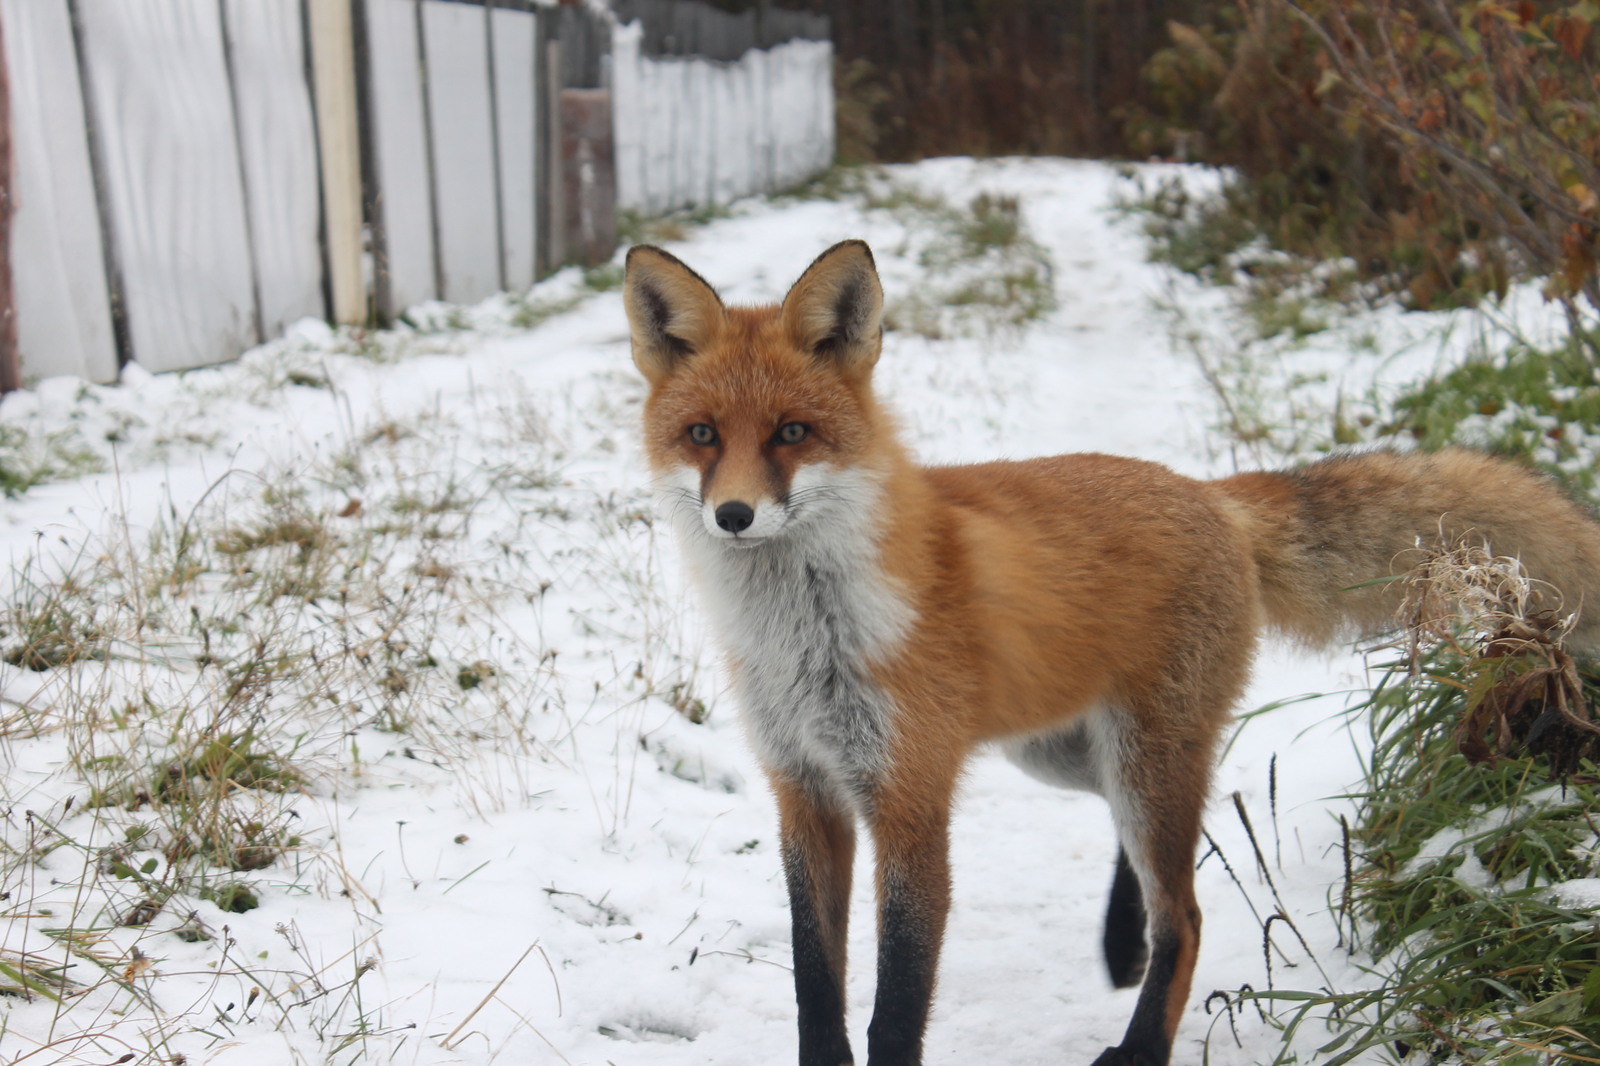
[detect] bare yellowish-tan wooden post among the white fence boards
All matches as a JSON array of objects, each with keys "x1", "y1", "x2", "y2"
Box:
[{"x1": 309, "y1": 0, "x2": 366, "y2": 325}]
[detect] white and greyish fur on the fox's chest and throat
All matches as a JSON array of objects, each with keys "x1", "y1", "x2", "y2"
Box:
[{"x1": 669, "y1": 469, "x2": 914, "y2": 804}]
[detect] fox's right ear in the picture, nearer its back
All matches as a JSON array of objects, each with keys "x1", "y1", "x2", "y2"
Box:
[{"x1": 782, "y1": 240, "x2": 883, "y2": 373}]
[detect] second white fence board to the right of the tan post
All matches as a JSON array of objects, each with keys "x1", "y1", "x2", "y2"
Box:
[{"x1": 422, "y1": 0, "x2": 501, "y2": 303}]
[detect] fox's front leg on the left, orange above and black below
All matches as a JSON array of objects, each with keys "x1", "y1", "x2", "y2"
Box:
[{"x1": 773, "y1": 775, "x2": 856, "y2": 1066}]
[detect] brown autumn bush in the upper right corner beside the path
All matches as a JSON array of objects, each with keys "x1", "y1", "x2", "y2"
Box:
[{"x1": 1130, "y1": 0, "x2": 1600, "y2": 306}]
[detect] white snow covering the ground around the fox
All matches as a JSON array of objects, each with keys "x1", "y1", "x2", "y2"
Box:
[{"x1": 0, "y1": 160, "x2": 1484, "y2": 1066}]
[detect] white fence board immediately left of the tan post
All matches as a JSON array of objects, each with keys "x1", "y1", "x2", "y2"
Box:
[{"x1": 226, "y1": 0, "x2": 328, "y2": 338}]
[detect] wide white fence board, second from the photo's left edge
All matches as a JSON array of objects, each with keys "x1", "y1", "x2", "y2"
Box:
[{"x1": 77, "y1": 0, "x2": 256, "y2": 370}]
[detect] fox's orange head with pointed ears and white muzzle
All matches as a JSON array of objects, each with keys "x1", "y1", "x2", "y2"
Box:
[{"x1": 622, "y1": 240, "x2": 883, "y2": 547}]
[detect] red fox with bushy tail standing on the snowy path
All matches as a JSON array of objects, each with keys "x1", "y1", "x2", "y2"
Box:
[{"x1": 624, "y1": 240, "x2": 1600, "y2": 1066}]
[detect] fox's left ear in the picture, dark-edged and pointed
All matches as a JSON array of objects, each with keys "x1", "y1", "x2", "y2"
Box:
[{"x1": 622, "y1": 245, "x2": 725, "y2": 384}]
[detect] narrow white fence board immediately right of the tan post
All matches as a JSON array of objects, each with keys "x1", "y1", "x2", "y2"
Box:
[{"x1": 363, "y1": 0, "x2": 438, "y2": 319}]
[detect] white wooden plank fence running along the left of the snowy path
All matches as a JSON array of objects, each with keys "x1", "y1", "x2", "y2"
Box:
[{"x1": 0, "y1": 0, "x2": 834, "y2": 387}]
